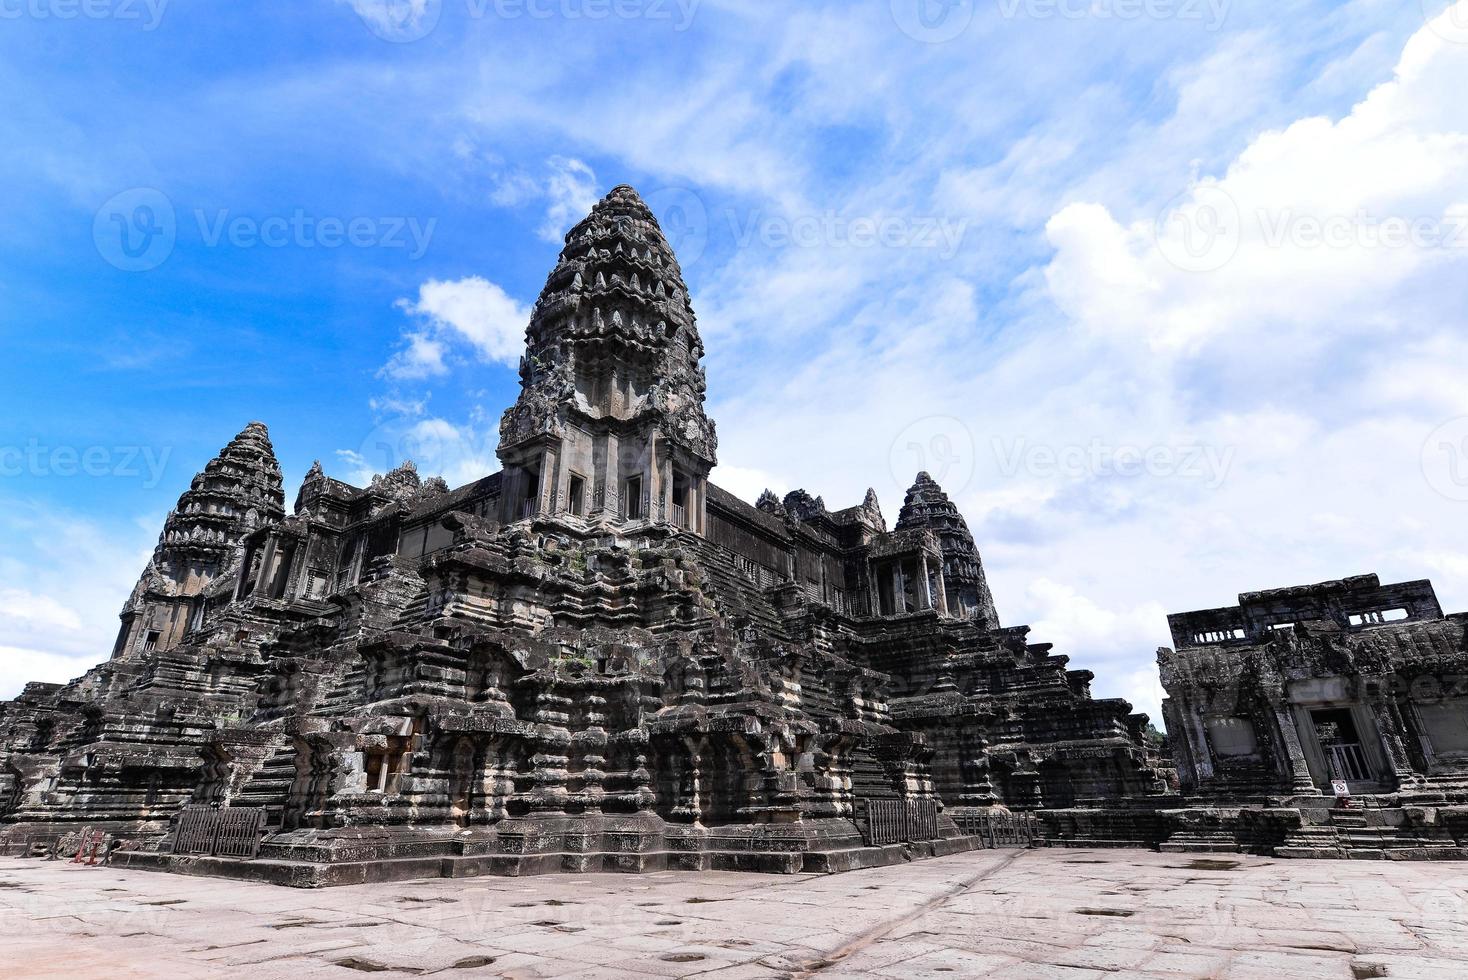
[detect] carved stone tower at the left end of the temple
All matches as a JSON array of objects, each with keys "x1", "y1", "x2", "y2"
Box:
[{"x1": 112, "y1": 423, "x2": 285, "y2": 657}]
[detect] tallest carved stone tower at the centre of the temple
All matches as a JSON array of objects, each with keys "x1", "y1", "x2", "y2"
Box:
[{"x1": 499, "y1": 185, "x2": 718, "y2": 533}]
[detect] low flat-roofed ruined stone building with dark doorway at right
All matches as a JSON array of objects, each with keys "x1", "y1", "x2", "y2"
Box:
[{"x1": 1158, "y1": 575, "x2": 1468, "y2": 857}]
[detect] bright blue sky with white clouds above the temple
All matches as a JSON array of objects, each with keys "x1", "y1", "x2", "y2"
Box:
[{"x1": 0, "y1": 0, "x2": 1468, "y2": 714}]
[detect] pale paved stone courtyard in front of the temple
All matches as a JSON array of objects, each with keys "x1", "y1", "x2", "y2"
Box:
[{"x1": 0, "y1": 849, "x2": 1468, "y2": 980}]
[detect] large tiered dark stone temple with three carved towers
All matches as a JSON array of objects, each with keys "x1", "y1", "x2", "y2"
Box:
[{"x1": 0, "y1": 186, "x2": 1168, "y2": 885}]
